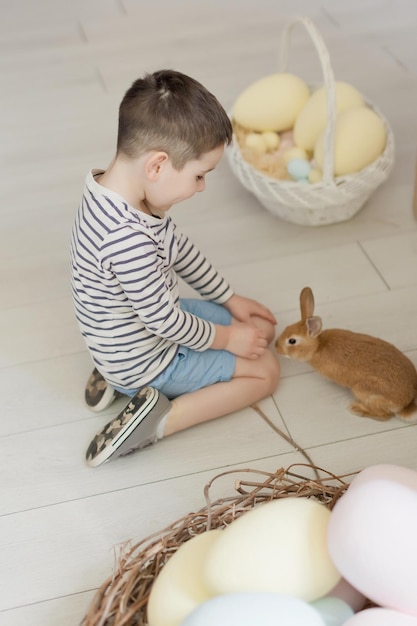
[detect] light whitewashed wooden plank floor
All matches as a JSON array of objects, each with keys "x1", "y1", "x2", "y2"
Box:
[{"x1": 0, "y1": 0, "x2": 417, "y2": 626}]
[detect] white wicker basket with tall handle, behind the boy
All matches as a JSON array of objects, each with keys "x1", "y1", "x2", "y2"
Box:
[{"x1": 227, "y1": 17, "x2": 394, "y2": 226}]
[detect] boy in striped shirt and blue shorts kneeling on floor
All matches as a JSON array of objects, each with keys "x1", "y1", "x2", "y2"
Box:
[{"x1": 71, "y1": 70, "x2": 279, "y2": 466}]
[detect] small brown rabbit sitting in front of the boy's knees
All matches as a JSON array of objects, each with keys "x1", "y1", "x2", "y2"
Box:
[{"x1": 275, "y1": 287, "x2": 417, "y2": 420}]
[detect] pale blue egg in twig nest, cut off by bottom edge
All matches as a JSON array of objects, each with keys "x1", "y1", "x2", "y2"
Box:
[{"x1": 181, "y1": 593, "x2": 325, "y2": 626}]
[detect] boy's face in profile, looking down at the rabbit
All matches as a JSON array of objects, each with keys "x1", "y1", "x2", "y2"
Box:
[{"x1": 146, "y1": 146, "x2": 224, "y2": 211}]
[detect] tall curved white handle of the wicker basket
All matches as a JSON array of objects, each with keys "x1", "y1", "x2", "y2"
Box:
[{"x1": 280, "y1": 16, "x2": 337, "y2": 184}]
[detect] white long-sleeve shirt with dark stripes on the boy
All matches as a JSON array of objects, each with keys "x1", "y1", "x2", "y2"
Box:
[{"x1": 71, "y1": 170, "x2": 233, "y2": 389}]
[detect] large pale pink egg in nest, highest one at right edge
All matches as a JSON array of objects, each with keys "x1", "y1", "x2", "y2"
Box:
[{"x1": 328, "y1": 466, "x2": 417, "y2": 617}]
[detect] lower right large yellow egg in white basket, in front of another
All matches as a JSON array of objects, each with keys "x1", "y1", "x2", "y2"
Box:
[{"x1": 314, "y1": 106, "x2": 387, "y2": 176}]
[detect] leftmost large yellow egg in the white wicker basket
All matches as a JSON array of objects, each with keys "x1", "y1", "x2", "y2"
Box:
[{"x1": 233, "y1": 72, "x2": 310, "y2": 132}]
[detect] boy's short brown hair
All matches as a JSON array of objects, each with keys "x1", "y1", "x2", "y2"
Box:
[{"x1": 117, "y1": 70, "x2": 233, "y2": 170}]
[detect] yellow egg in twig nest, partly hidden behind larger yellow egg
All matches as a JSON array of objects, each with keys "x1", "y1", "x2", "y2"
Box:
[{"x1": 147, "y1": 530, "x2": 222, "y2": 626}]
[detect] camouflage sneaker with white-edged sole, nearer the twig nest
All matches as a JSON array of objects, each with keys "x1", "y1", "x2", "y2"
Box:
[{"x1": 86, "y1": 387, "x2": 171, "y2": 467}]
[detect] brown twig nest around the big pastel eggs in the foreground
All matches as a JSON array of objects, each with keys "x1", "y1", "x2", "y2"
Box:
[{"x1": 82, "y1": 464, "x2": 374, "y2": 626}]
